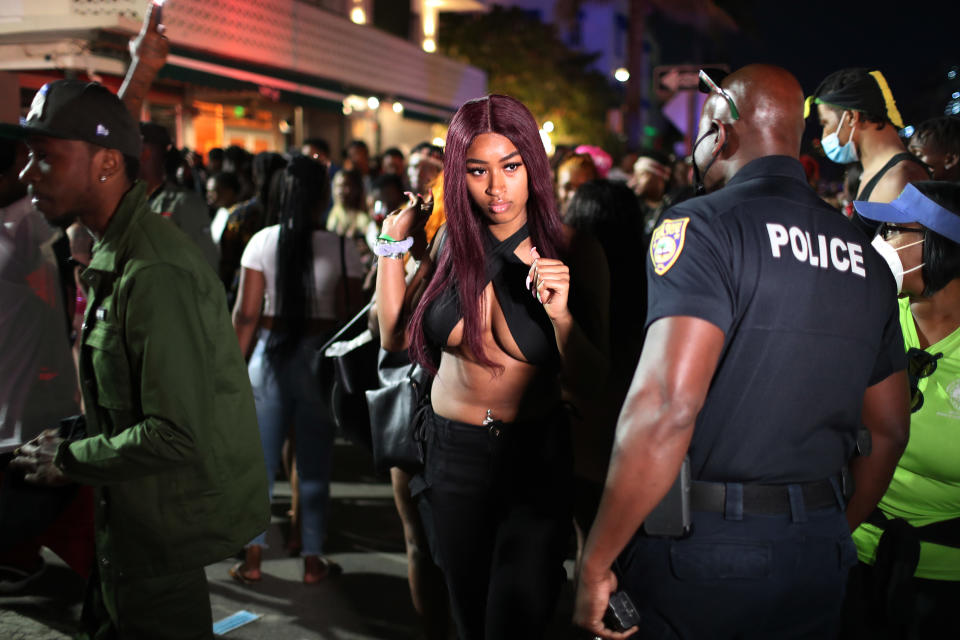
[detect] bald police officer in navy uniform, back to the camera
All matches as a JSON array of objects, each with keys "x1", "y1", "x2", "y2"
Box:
[{"x1": 575, "y1": 65, "x2": 909, "y2": 638}]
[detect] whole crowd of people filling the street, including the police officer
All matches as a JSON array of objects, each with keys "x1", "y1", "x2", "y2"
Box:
[{"x1": 0, "y1": 5, "x2": 960, "y2": 640}]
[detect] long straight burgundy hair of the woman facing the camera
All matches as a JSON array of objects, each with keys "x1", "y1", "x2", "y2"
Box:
[{"x1": 408, "y1": 95, "x2": 563, "y2": 373}]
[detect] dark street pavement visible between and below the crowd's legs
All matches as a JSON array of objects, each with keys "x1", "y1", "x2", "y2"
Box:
[{"x1": 0, "y1": 439, "x2": 572, "y2": 640}]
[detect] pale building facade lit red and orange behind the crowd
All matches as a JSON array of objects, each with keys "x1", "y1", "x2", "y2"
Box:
[{"x1": 0, "y1": 0, "x2": 486, "y2": 159}]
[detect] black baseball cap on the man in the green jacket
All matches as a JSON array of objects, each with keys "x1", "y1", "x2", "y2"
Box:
[{"x1": 4, "y1": 80, "x2": 141, "y2": 158}]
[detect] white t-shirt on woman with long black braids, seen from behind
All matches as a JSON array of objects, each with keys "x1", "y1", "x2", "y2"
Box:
[{"x1": 240, "y1": 224, "x2": 363, "y2": 319}]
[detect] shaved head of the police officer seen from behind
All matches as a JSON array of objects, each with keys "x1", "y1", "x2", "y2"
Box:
[{"x1": 694, "y1": 64, "x2": 804, "y2": 190}]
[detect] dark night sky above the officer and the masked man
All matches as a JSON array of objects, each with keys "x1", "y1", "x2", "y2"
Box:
[{"x1": 658, "y1": 0, "x2": 960, "y2": 124}]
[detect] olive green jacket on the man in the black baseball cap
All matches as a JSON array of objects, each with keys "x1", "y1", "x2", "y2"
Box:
[{"x1": 55, "y1": 182, "x2": 269, "y2": 576}]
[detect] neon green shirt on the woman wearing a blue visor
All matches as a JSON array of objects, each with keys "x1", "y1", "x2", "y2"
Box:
[{"x1": 853, "y1": 298, "x2": 960, "y2": 580}]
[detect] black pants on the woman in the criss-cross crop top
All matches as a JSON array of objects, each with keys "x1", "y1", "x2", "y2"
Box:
[{"x1": 411, "y1": 409, "x2": 572, "y2": 640}]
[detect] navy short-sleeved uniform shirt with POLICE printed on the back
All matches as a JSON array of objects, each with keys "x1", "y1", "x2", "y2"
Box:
[{"x1": 647, "y1": 156, "x2": 906, "y2": 484}]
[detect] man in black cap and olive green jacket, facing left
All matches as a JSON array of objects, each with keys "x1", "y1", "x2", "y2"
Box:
[{"x1": 13, "y1": 80, "x2": 269, "y2": 639}]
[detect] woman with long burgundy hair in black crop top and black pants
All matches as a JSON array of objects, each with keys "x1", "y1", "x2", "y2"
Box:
[{"x1": 377, "y1": 95, "x2": 609, "y2": 639}]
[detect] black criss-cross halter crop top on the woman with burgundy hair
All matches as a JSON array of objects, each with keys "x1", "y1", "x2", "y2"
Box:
[{"x1": 423, "y1": 224, "x2": 559, "y2": 365}]
